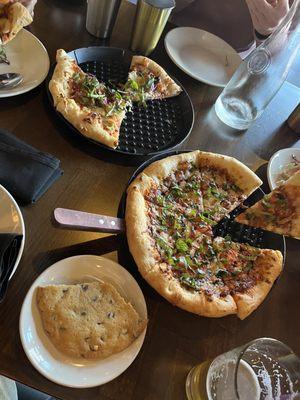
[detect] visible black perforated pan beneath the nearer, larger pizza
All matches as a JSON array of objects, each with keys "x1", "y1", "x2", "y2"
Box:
[{"x1": 118, "y1": 151, "x2": 286, "y2": 284}]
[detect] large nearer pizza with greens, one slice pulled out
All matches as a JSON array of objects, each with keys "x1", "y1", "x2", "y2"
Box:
[{"x1": 126, "y1": 151, "x2": 282, "y2": 319}]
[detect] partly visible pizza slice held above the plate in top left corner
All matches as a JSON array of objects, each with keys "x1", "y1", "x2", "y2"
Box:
[{"x1": 0, "y1": 3, "x2": 32, "y2": 44}]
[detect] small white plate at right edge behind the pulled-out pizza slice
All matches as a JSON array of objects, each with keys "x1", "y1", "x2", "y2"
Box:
[{"x1": 267, "y1": 147, "x2": 300, "y2": 190}]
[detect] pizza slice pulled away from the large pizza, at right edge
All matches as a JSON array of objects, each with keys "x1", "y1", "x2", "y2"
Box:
[{"x1": 235, "y1": 171, "x2": 300, "y2": 238}]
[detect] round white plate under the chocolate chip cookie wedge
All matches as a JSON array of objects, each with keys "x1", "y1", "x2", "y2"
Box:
[{"x1": 20, "y1": 255, "x2": 147, "y2": 388}]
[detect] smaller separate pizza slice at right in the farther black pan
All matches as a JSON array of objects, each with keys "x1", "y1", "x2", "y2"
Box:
[{"x1": 125, "y1": 56, "x2": 182, "y2": 104}]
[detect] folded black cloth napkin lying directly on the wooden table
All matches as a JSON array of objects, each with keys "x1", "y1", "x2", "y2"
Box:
[{"x1": 0, "y1": 129, "x2": 63, "y2": 203}]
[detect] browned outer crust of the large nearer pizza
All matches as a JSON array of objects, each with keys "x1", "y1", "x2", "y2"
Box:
[{"x1": 125, "y1": 150, "x2": 282, "y2": 319}]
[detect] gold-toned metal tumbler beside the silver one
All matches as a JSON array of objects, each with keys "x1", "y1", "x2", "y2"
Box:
[{"x1": 130, "y1": 0, "x2": 175, "y2": 56}]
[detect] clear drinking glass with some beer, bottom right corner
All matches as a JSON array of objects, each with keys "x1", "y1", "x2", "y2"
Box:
[{"x1": 186, "y1": 338, "x2": 300, "y2": 400}]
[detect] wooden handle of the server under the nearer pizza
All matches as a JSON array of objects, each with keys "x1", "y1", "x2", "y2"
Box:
[{"x1": 53, "y1": 208, "x2": 125, "y2": 233}]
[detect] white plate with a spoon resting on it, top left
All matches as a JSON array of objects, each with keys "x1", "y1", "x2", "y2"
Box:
[{"x1": 0, "y1": 29, "x2": 50, "y2": 98}]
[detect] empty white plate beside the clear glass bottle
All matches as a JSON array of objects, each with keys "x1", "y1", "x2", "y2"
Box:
[{"x1": 165, "y1": 27, "x2": 242, "y2": 87}]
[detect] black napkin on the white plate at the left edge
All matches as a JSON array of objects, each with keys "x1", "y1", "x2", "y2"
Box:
[{"x1": 0, "y1": 233, "x2": 23, "y2": 302}]
